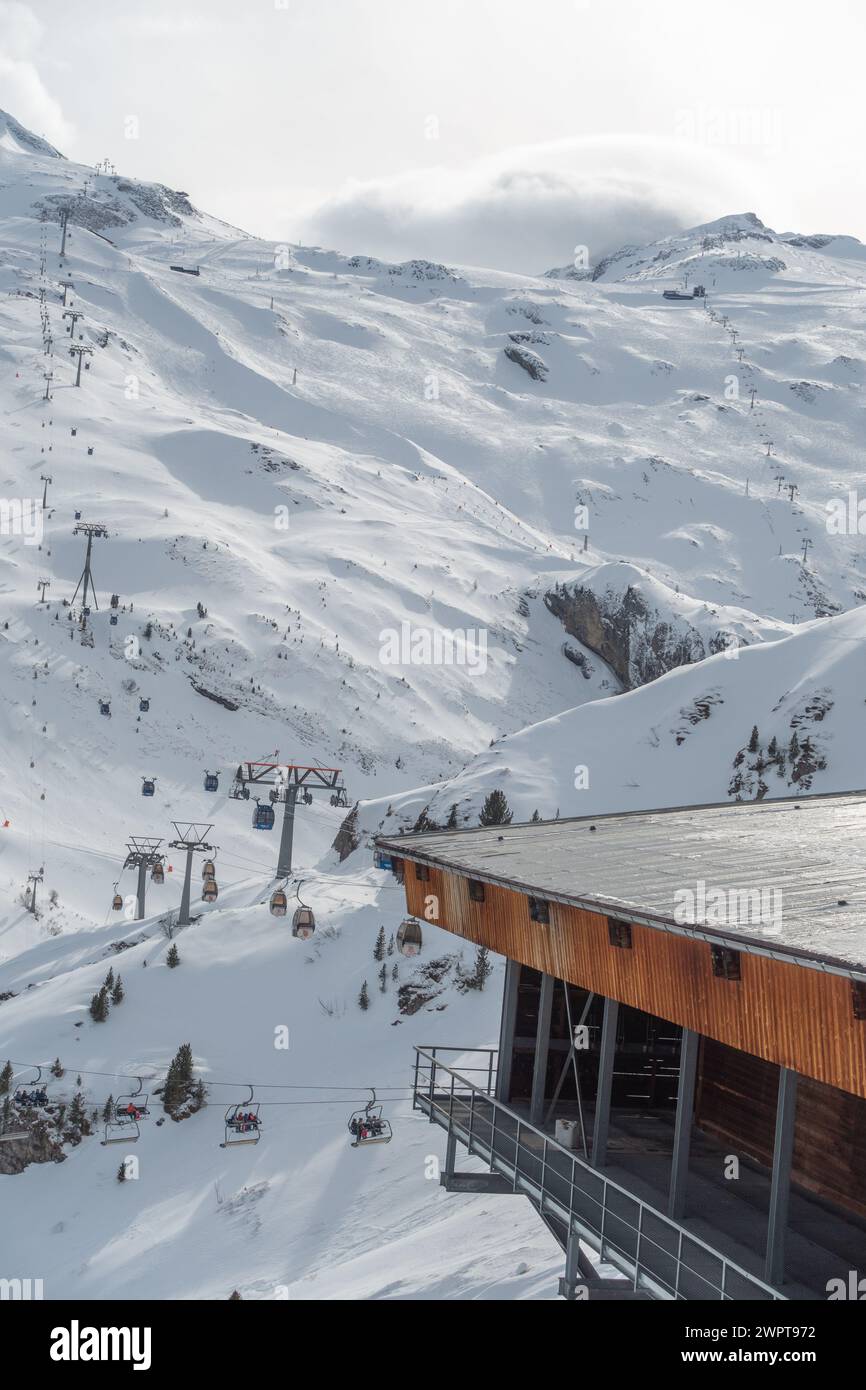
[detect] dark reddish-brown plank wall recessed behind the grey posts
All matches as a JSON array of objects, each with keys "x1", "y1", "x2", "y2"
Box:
[{"x1": 695, "y1": 1038, "x2": 866, "y2": 1216}]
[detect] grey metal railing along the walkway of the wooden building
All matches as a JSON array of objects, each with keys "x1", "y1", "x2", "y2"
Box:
[{"x1": 413, "y1": 1047, "x2": 787, "y2": 1301}]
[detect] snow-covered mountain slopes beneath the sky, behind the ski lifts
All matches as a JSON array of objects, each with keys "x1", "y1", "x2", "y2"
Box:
[{"x1": 0, "y1": 115, "x2": 866, "y2": 1297}]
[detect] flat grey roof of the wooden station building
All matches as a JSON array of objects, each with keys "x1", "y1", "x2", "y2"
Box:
[{"x1": 377, "y1": 792, "x2": 866, "y2": 976}]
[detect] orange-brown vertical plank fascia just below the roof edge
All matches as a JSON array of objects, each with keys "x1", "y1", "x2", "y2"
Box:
[{"x1": 405, "y1": 859, "x2": 866, "y2": 1097}]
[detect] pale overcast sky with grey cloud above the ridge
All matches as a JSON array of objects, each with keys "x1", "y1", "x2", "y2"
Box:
[{"x1": 0, "y1": 0, "x2": 866, "y2": 271}]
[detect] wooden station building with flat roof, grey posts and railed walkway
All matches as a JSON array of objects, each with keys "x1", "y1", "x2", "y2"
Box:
[{"x1": 377, "y1": 794, "x2": 866, "y2": 1298}]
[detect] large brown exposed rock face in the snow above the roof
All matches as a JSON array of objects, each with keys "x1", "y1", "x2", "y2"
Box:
[{"x1": 545, "y1": 572, "x2": 728, "y2": 689}]
